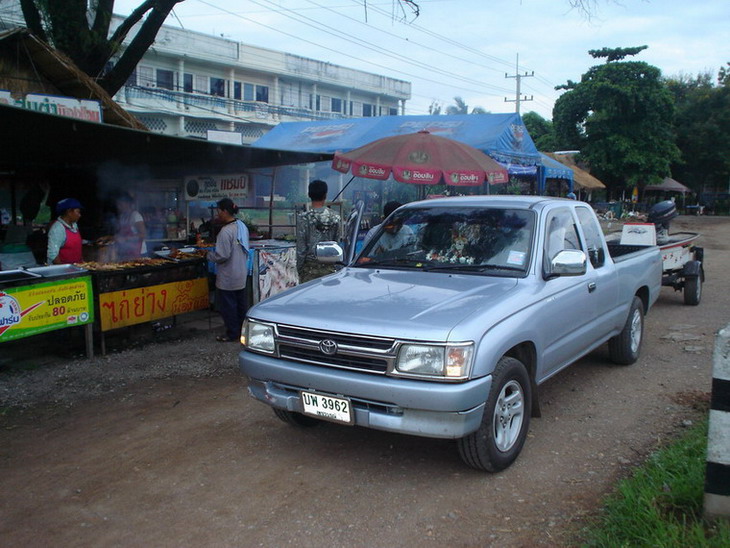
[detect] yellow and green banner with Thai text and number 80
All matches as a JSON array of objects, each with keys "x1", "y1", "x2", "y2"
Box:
[{"x1": 0, "y1": 276, "x2": 94, "y2": 342}]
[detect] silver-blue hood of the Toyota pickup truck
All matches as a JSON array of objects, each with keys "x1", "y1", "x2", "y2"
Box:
[{"x1": 248, "y1": 268, "x2": 518, "y2": 341}]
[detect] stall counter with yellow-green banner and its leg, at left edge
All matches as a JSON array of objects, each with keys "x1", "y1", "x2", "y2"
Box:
[{"x1": 0, "y1": 265, "x2": 95, "y2": 358}]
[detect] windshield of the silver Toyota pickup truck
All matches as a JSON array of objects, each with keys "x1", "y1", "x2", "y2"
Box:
[{"x1": 355, "y1": 207, "x2": 534, "y2": 276}]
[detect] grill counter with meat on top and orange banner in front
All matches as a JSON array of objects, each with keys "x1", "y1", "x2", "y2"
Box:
[{"x1": 78, "y1": 251, "x2": 210, "y2": 354}]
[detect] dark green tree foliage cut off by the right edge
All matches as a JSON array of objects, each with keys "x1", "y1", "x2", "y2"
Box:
[{"x1": 666, "y1": 68, "x2": 730, "y2": 192}]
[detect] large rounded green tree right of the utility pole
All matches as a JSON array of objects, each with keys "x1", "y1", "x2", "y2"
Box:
[{"x1": 553, "y1": 46, "x2": 679, "y2": 194}]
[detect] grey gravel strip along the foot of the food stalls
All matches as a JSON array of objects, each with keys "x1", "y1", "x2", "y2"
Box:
[{"x1": 0, "y1": 312, "x2": 239, "y2": 409}]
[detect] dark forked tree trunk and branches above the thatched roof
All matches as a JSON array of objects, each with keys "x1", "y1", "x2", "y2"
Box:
[{"x1": 20, "y1": 0, "x2": 183, "y2": 95}]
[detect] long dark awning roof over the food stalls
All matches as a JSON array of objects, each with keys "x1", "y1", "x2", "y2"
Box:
[{"x1": 0, "y1": 104, "x2": 332, "y2": 178}]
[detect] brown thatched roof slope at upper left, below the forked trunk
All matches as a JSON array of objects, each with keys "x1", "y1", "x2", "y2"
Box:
[{"x1": 0, "y1": 28, "x2": 147, "y2": 130}]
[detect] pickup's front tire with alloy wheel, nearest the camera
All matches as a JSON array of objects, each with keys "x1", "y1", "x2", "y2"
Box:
[{"x1": 457, "y1": 356, "x2": 532, "y2": 472}]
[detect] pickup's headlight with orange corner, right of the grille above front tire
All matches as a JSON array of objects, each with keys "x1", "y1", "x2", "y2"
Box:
[{"x1": 395, "y1": 343, "x2": 474, "y2": 379}]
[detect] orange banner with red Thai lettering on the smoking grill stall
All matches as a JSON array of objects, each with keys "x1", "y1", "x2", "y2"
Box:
[{"x1": 99, "y1": 278, "x2": 209, "y2": 331}]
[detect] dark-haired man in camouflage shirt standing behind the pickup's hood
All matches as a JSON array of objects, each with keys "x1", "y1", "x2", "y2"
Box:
[{"x1": 297, "y1": 180, "x2": 340, "y2": 283}]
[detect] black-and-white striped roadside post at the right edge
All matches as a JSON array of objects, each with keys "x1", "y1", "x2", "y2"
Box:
[{"x1": 705, "y1": 324, "x2": 730, "y2": 519}]
